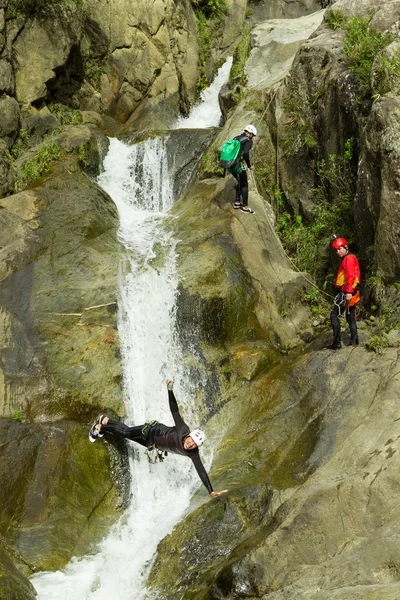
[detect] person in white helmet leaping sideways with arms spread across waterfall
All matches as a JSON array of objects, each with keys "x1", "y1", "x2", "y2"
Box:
[{"x1": 89, "y1": 380, "x2": 228, "y2": 496}]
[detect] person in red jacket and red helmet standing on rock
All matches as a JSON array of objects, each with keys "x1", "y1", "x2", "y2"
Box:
[{"x1": 326, "y1": 237, "x2": 360, "y2": 350}]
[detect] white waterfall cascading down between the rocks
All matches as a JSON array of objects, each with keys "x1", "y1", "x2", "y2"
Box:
[{"x1": 31, "y1": 57, "x2": 230, "y2": 600}]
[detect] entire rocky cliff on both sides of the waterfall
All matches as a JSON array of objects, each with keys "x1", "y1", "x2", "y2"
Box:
[{"x1": 0, "y1": 0, "x2": 400, "y2": 600}]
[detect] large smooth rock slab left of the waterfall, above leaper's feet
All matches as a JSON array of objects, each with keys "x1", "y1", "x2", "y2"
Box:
[{"x1": 0, "y1": 164, "x2": 122, "y2": 418}]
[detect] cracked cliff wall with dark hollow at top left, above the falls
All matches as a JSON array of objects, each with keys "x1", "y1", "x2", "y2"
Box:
[{"x1": 0, "y1": 0, "x2": 198, "y2": 122}]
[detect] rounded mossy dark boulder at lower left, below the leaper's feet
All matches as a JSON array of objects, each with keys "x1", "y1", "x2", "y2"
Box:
[{"x1": 0, "y1": 419, "x2": 128, "y2": 574}]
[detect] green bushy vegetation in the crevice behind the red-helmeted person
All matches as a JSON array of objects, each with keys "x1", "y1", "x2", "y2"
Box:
[{"x1": 275, "y1": 138, "x2": 354, "y2": 285}]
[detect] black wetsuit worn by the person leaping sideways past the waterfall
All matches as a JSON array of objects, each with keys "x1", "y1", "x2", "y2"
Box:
[{"x1": 101, "y1": 390, "x2": 213, "y2": 494}]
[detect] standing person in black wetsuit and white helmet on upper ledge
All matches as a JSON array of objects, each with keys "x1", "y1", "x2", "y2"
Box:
[{"x1": 229, "y1": 125, "x2": 257, "y2": 215}]
